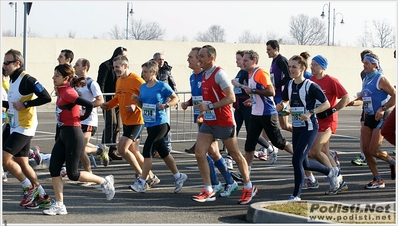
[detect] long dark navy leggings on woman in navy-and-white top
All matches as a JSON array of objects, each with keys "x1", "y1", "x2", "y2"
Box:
[{"x1": 292, "y1": 123, "x2": 330, "y2": 197}]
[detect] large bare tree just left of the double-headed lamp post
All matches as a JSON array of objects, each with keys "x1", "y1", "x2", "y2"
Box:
[{"x1": 289, "y1": 14, "x2": 326, "y2": 45}]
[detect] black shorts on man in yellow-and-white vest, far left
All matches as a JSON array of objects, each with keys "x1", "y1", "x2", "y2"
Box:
[{"x1": 3, "y1": 132, "x2": 33, "y2": 157}]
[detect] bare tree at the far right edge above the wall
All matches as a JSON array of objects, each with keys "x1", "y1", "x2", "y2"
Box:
[{"x1": 372, "y1": 19, "x2": 395, "y2": 48}]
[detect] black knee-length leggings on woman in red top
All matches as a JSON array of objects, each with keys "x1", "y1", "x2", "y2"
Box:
[{"x1": 49, "y1": 126, "x2": 84, "y2": 181}]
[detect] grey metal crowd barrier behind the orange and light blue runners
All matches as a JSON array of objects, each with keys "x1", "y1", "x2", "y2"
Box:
[{"x1": 96, "y1": 92, "x2": 198, "y2": 146}]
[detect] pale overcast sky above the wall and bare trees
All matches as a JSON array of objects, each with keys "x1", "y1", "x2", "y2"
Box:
[{"x1": 1, "y1": 0, "x2": 398, "y2": 46}]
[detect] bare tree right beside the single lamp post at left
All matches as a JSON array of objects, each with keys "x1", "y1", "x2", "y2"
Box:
[{"x1": 129, "y1": 19, "x2": 165, "y2": 40}]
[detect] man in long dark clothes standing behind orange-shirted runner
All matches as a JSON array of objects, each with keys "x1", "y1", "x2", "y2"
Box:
[{"x1": 97, "y1": 47, "x2": 127, "y2": 160}]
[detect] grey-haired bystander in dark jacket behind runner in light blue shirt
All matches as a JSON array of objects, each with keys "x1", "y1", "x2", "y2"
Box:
[{"x1": 153, "y1": 52, "x2": 178, "y2": 151}]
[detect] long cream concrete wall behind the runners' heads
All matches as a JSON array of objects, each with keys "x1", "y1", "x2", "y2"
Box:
[{"x1": 0, "y1": 37, "x2": 397, "y2": 101}]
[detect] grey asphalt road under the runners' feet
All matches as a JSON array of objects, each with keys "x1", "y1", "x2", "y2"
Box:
[{"x1": 2, "y1": 107, "x2": 396, "y2": 225}]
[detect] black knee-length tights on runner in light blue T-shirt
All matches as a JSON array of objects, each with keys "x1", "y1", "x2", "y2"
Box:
[{"x1": 142, "y1": 123, "x2": 170, "y2": 159}]
